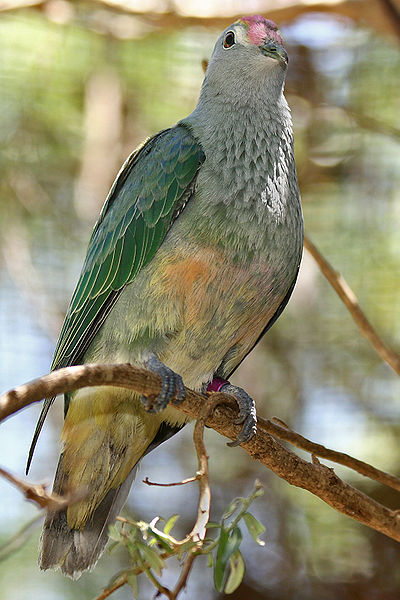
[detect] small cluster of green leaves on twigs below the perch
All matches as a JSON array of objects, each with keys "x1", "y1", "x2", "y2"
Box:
[{"x1": 104, "y1": 481, "x2": 265, "y2": 598}]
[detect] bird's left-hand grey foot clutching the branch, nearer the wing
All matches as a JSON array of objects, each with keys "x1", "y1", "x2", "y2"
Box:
[{"x1": 140, "y1": 354, "x2": 186, "y2": 413}]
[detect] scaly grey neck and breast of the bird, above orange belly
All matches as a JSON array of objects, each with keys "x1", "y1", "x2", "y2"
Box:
[{"x1": 177, "y1": 80, "x2": 300, "y2": 260}]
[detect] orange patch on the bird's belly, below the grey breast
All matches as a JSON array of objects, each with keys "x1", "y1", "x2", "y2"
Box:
[{"x1": 152, "y1": 247, "x2": 275, "y2": 350}]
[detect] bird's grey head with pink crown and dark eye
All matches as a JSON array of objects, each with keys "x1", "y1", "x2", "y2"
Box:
[{"x1": 206, "y1": 15, "x2": 288, "y2": 100}]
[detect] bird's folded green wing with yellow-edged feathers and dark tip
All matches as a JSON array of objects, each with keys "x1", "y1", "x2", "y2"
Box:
[{"x1": 27, "y1": 125, "x2": 205, "y2": 471}]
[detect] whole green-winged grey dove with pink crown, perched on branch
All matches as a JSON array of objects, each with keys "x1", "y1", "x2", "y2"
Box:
[{"x1": 28, "y1": 15, "x2": 303, "y2": 578}]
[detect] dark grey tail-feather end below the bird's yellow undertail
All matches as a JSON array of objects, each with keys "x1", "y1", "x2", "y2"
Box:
[{"x1": 39, "y1": 456, "x2": 136, "y2": 579}]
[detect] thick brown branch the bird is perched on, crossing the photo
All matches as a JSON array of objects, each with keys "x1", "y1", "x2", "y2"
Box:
[{"x1": 0, "y1": 364, "x2": 400, "y2": 541}]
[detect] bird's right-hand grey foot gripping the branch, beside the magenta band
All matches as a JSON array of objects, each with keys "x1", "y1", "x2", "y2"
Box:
[{"x1": 207, "y1": 377, "x2": 257, "y2": 446}]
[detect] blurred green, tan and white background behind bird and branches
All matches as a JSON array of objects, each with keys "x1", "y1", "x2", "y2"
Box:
[{"x1": 0, "y1": 0, "x2": 400, "y2": 600}]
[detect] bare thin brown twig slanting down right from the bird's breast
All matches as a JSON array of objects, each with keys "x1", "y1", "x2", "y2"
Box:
[{"x1": 304, "y1": 237, "x2": 400, "y2": 375}]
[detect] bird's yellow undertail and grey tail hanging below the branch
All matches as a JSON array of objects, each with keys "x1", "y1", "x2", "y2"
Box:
[{"x1": 39, "y1": 388, "x2": 181, "y2": 579}]
